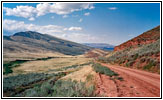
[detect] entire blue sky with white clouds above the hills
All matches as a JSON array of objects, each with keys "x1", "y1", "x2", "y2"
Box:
[{"x1": 3, "y1": 3, "x2": 160, "y2": 45}]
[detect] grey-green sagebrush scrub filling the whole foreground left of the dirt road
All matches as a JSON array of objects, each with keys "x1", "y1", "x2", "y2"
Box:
[{"x1": 3, "y1": 63, "x2": 96, "y2": 97}]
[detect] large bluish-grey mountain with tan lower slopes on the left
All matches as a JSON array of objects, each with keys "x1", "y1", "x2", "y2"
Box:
[{"x1": 3, "y1": 31, "x2": 92, "y2": 55}]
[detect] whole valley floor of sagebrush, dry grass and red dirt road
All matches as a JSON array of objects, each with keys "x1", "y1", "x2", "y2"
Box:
[{"x1": 3, "y1": 52, "x2": 160, "y2": 97}]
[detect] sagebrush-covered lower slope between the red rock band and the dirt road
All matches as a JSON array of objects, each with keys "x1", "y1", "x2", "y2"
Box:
[{"x1": 98, "y1": 39, "x2": 160, "y2": 73}]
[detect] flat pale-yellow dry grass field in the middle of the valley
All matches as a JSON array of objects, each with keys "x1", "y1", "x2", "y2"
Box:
[{"x1": 13, "y1": 57, "x2": 91, "y2": 74}]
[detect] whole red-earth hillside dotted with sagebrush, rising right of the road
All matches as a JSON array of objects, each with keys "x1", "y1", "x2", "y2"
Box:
[{"x1": 99, "y1": 26, "x2": 160, "y2": 73}]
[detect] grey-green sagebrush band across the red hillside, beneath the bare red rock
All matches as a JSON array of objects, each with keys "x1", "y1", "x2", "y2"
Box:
[{"x1": 106, "y1": 39, "x2": 160, "y2": 67}]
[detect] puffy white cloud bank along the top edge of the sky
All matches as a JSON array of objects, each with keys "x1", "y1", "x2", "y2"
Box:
[{"x1": 3, "y1": 3, "x2": 95, "y2": 19}]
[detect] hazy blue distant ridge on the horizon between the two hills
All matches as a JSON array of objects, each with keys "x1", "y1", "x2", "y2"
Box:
[{"x1": 83, "y1": 43, "x2": 114, "y2": 50}]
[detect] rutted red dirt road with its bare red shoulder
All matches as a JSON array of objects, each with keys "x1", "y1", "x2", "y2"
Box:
[{"x1": 97, "y1": 64, "x2": 160, "y2": 97}]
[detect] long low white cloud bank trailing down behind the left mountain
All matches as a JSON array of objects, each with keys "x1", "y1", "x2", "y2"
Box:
[{"x1": 3, "y1": 19, "x2": 101, "y2": 43}]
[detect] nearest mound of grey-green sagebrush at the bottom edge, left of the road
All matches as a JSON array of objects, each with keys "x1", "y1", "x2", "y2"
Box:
[{"x1": 16, "y1": 80, "x2": 96, "y2": 97}]
